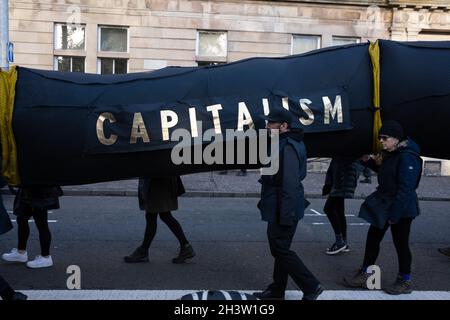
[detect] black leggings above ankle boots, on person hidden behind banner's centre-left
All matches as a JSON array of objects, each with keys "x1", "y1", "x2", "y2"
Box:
[{"x1": 142, "y1": 211, "x2": 188, "y2": 250}]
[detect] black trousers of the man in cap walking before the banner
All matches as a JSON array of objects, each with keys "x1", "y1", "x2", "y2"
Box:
[{"x1": 267, "y1": 223, "x2": 319, "y2": 294}]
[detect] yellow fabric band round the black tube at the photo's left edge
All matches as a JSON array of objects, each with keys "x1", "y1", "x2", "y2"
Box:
[{"x1": 0, "y1": 67, "x2": 20, "y2": 186}]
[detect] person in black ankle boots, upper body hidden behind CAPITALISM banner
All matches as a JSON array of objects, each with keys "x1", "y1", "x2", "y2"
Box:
[{"x1": 124, "y1": 176, "x2": 195, "y2": 263}]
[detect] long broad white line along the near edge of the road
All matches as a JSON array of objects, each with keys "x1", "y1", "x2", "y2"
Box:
[{"x1": 19, "y1": 290, "x2": 450, "y2": 300}]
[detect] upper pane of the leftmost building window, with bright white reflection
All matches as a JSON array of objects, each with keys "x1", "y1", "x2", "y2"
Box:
[{"x1": 55, "y1": 23, "x2": 86, "y2": 50}]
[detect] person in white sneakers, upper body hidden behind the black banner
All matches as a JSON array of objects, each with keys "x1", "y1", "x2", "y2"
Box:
[{"x1": 2, "y1": 186, "x2": 63, "y2": 268}]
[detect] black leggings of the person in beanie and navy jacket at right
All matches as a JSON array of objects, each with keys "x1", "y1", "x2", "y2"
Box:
[{"x1": 363, "y1": 218, "x2": 412, "y2": 274}]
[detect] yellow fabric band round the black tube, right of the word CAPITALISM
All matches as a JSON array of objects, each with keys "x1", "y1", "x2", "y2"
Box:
[{"x1": 369, "y1": 40, "x2": 382, "y2": 153}]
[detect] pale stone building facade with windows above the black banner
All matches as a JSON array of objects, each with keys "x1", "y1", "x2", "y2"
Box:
[{"x1": 9, "y1": 0, "x2": 450, "y2": 174}]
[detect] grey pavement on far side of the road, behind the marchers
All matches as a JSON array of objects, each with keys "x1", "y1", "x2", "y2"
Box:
[{"x1": 1, "y1": 170, "x2": 450, "y2": 201}]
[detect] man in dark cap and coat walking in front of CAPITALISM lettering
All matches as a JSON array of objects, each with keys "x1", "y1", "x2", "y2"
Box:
[{"x1": 254, "y1": 109, "x2": 323, "y2": 300}]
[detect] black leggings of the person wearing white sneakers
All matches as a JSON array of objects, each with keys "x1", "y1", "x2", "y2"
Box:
[{"x1": 17, "y1": 207, "x2": 52, "y2": 257}]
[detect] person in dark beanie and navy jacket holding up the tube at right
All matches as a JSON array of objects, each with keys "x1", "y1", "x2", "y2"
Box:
[{"x1": 344, "y1": 120, "x2": 422, "y2": 295}]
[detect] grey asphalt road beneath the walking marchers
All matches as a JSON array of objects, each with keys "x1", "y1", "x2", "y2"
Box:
[{"x1": 0, "y1": 196, "x2": 450, "y2": 291}]
